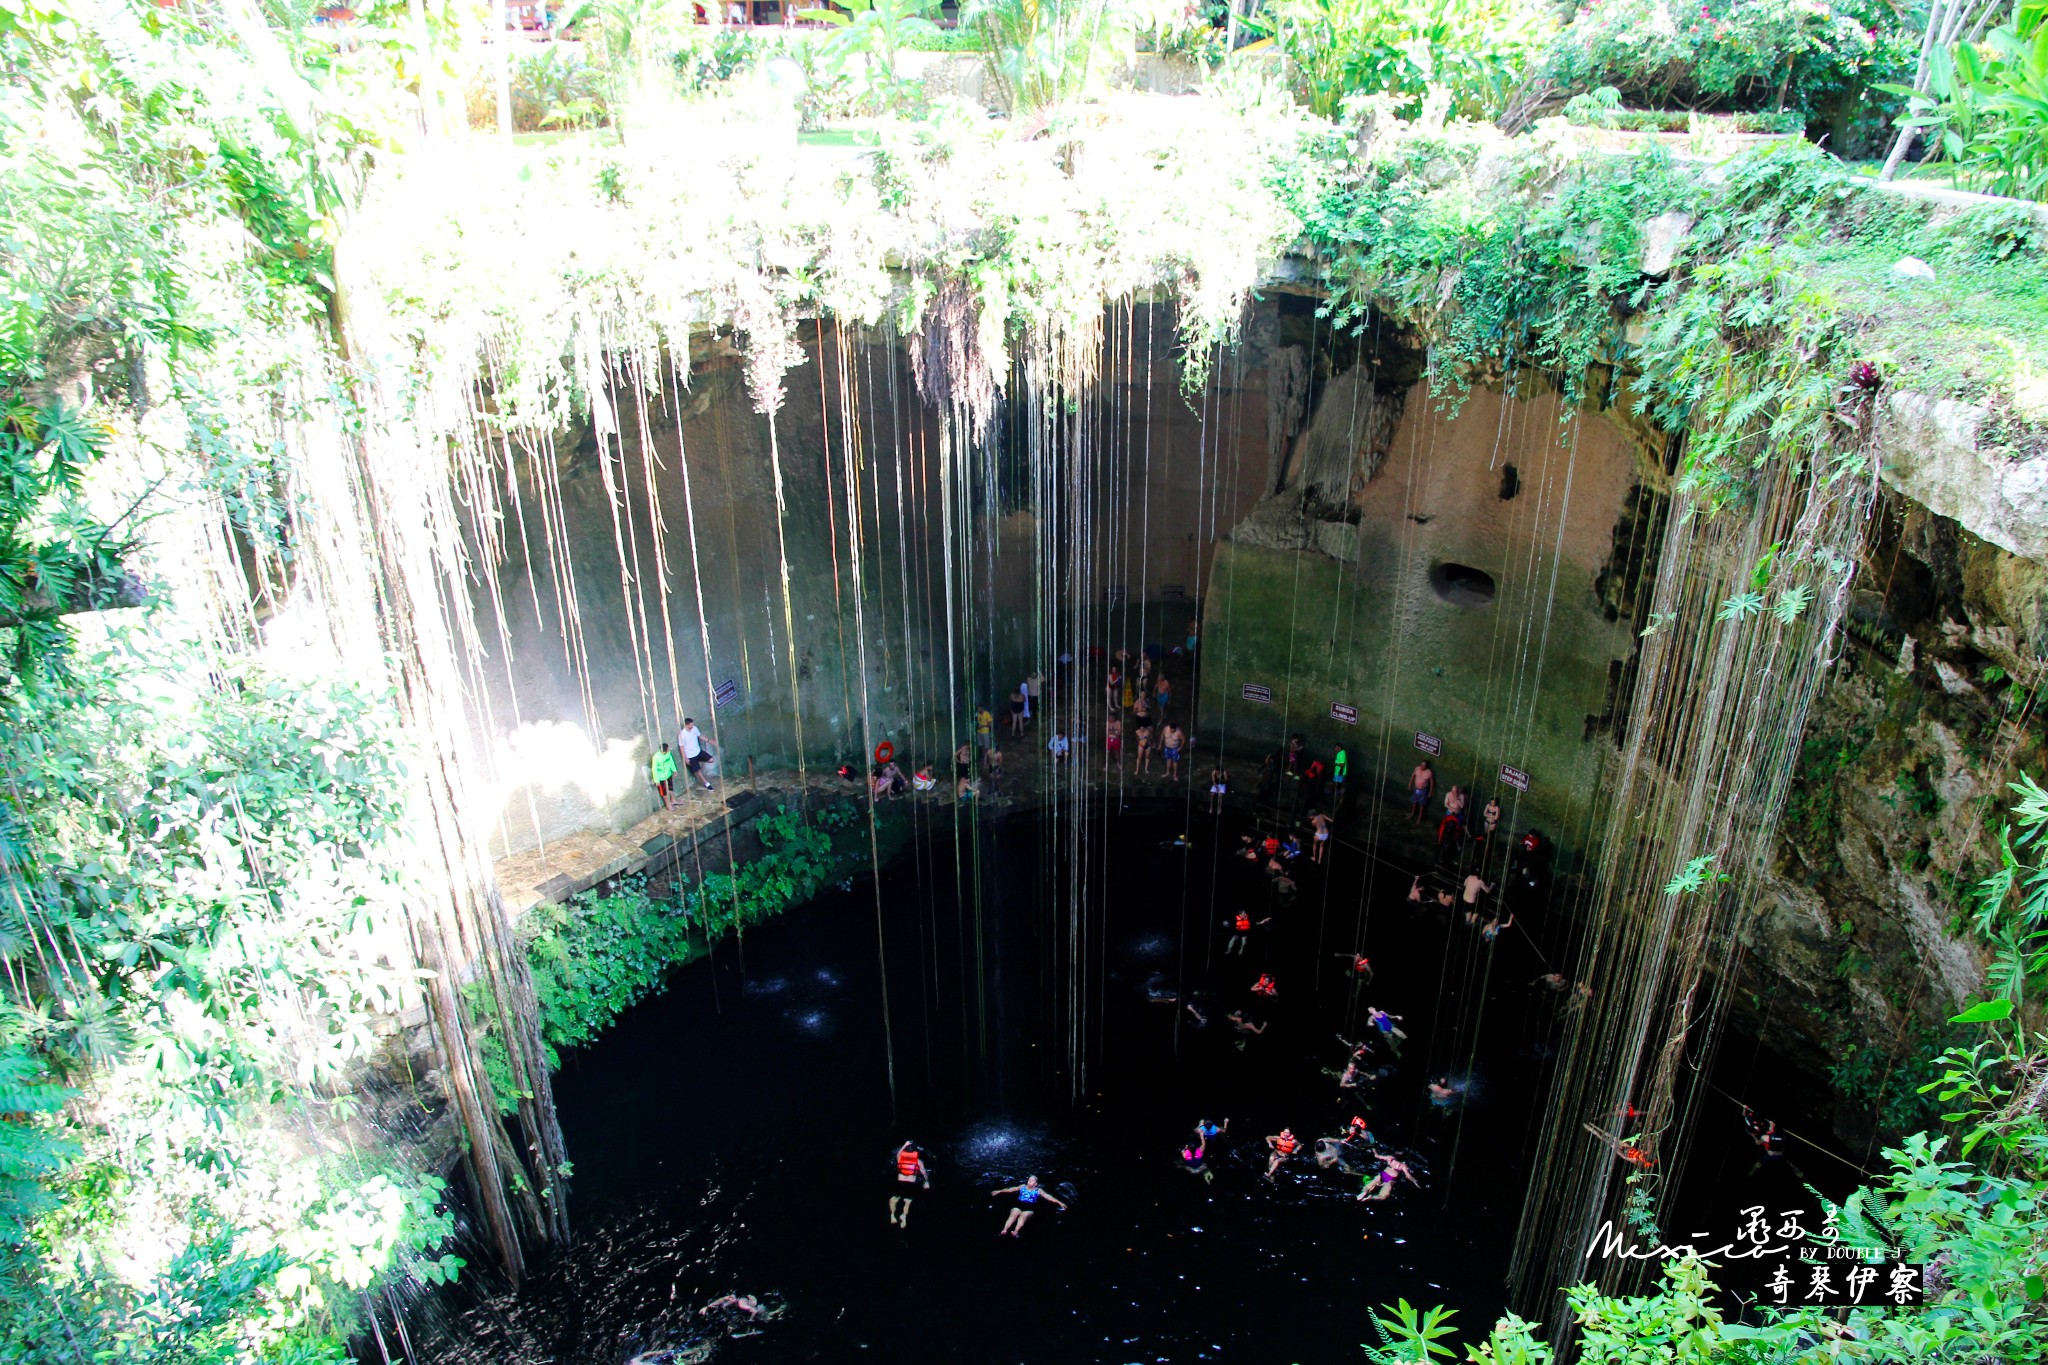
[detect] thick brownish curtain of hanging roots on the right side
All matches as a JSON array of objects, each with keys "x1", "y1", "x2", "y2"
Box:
[{"x1": 1511, "y1": 431, "x2": 1876, "y2": 1332}]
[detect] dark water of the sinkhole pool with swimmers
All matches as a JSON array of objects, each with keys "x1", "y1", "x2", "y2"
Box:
[{"x1": 407, "y1": 808, "x2": 1851, "y2": 1365}]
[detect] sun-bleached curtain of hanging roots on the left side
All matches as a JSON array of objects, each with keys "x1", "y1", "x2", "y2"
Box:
[{"x1": 313, "y1": 297, "x2": 569, "y2": 1283}]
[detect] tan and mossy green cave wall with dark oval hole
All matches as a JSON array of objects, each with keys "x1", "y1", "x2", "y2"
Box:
[{"x1": 1200, "y1": 370, "x2": 1659, "y2": 853}]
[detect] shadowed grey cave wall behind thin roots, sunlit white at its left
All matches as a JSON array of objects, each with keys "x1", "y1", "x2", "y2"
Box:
[{"x1": 475, "y1": 317, "x2": 1268, "y2": 853}]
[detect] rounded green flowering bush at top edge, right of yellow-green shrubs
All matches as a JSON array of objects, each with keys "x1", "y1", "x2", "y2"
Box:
[{"x1": 1542, "y1": 0, "x2": 1917, "y2": 122}]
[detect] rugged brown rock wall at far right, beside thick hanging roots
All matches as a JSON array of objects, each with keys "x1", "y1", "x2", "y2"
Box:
[{"x1": 1735, "y1": 491, "x2": 2048, "y2": 1150}]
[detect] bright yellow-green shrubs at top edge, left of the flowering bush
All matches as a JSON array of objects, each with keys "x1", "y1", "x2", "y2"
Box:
[{"x1": 1247, "y1": 0, "x2": 1548, "y2": 119}]
